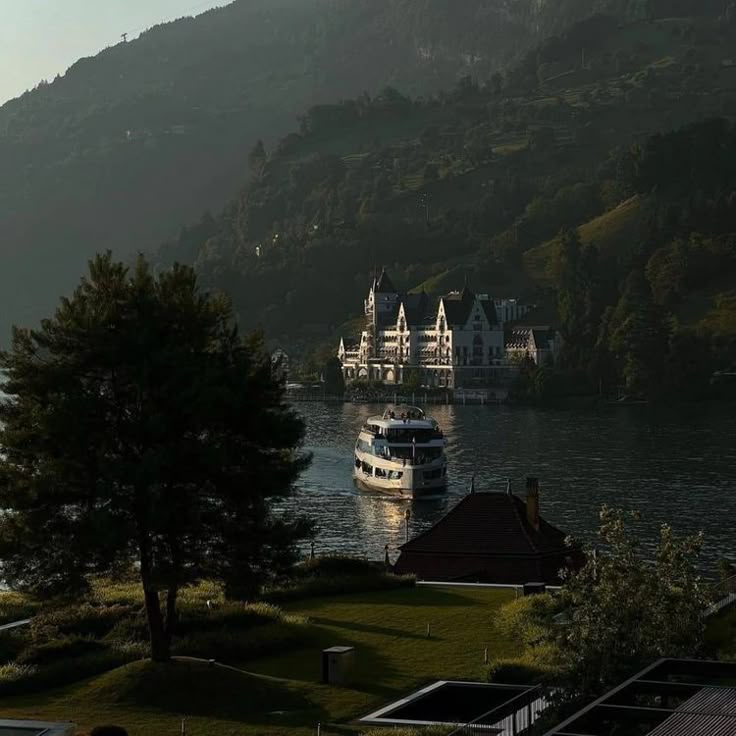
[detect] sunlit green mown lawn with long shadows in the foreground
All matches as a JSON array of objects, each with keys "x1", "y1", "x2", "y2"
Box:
[{"x1": 0, "y1": 587, "x2": 516, "y2": 736}]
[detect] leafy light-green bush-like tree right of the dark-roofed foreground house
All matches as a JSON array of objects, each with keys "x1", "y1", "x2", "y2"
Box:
[{"x1": 547, "y1": 506, "x2": 708, "y2": 701}]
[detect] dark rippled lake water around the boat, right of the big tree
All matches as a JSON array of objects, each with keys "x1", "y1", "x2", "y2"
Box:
[{"x1": 286, "y1": 403, "x2": 736, "y2": 572}]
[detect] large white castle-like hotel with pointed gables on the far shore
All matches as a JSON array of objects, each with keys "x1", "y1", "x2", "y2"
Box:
[{"x1": 338, "y1": 269, "x2": 560, "y2": 389}]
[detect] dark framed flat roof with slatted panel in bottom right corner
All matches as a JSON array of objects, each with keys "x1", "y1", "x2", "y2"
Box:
[{"x1": 545, "y1": 659, "x2": 736, "y2": 736}]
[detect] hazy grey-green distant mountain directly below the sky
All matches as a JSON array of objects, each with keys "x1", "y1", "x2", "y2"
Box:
[{"x1": 0, "y1": 0, "x2": 646, "y2": 335}]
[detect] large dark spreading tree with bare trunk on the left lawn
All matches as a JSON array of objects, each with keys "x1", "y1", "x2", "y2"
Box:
[{"x1": 0, "y1": 253, "x2": 309, "y2": 661}]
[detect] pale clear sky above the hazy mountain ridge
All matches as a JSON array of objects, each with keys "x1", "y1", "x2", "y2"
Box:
[{"x1": 0, "y1": 0, "x2": 227, "y2": 104}]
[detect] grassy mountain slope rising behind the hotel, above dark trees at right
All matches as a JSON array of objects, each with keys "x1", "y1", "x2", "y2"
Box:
[{"x1": 161, "y1": 8, "x2": 736, "y2": 340}]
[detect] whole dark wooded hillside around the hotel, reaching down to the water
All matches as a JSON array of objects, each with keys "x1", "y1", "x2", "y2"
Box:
[{"x1": 160, "y1": 7, "x2": 736, "y2": 398}]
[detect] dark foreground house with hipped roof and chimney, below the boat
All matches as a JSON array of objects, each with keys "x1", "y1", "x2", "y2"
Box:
[{"x1": 395, "y1": 478, "x2": 584, "y2": 585}]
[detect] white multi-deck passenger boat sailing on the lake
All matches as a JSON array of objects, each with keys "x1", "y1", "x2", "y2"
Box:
[{"x1": 353, "y1": 406, "x2": 447, "y2": 498}]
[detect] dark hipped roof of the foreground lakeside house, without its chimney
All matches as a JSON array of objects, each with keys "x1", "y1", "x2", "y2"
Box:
[{"x1": 401, "y1": 493, "x2": 568, "y2": 557}]
